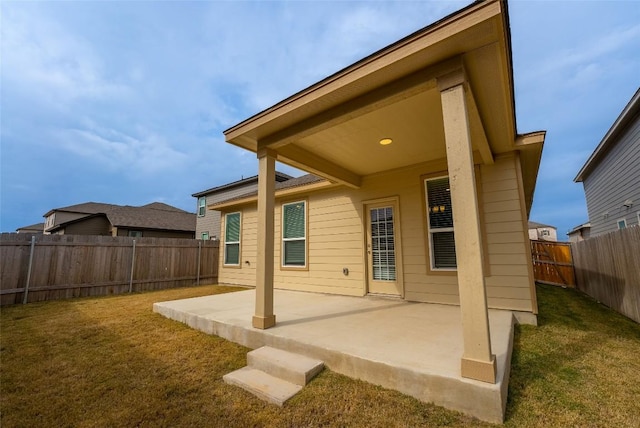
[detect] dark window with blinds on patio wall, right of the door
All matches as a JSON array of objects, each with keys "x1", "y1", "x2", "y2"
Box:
[{"x1": 425, "y1": 177, "x2": 457, "y2": 270}]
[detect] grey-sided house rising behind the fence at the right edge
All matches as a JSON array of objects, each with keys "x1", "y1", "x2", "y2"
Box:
[{"x1": 574, "y1": 89, "x2": 640, "y2": 236}]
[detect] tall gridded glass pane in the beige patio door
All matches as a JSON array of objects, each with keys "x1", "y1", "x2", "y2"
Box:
[{"x1": 369, "y1": 207, "x2": 396, "y2": 281}]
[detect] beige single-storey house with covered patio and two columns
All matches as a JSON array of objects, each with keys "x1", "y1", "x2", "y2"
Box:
[{"x1": 215, "y1": 1, "x2": 545, "y2": 383}]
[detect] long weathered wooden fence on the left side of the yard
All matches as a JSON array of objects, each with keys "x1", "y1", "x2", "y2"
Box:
[{"x1": 0, "y1": 233, "x2": 218, "y2": 305}]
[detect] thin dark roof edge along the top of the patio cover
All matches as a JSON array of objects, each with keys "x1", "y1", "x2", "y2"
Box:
[{"x1": 223, "y1": 0, "x2": 498, "y2": 142}]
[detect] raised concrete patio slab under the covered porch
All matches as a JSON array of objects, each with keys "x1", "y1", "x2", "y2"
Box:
[{"x1": 153, "y1": 290, "x2": 515, "y2": 423}]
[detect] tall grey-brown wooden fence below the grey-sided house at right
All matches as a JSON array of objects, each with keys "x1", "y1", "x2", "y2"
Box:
[{"x1": 571, "y1": 226, "x2": 640, "y2": 323}]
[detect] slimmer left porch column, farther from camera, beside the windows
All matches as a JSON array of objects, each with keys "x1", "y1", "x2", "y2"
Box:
[{"x1": 252, "y1": 149, "x2": 276, "y2": 330}]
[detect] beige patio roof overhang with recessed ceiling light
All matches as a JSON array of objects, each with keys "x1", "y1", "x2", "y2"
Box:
[{"x1": 224, "y1": 0, "x2": 544, "y2": 208}]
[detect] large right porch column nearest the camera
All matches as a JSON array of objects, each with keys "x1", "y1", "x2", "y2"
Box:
[{"x1": 438, "y1": 70, "x2": 496, "y2": 383}]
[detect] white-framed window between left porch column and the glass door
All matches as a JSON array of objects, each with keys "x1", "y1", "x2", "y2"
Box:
[{"x1": 282, "y1": 201, "x2": 307, "y2": 267}]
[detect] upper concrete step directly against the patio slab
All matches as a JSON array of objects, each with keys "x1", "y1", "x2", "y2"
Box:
[{"x1": 247, "y1": 346, "x2": 324, "y2": 386}]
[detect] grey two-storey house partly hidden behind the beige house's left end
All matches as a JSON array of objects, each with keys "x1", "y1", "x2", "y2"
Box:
[{"x1": 191, "y1": 171, "x2": 293, "y2": 240}]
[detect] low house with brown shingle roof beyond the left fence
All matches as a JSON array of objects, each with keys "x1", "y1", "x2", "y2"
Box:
[{"x1": 45, "y1": 202, "x2": 196, "y2": 238}]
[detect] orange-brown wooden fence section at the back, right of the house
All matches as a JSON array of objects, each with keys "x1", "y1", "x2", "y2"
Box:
[{"x1": 531, "y1": 241, "x2": 576, "y2": 288}]
